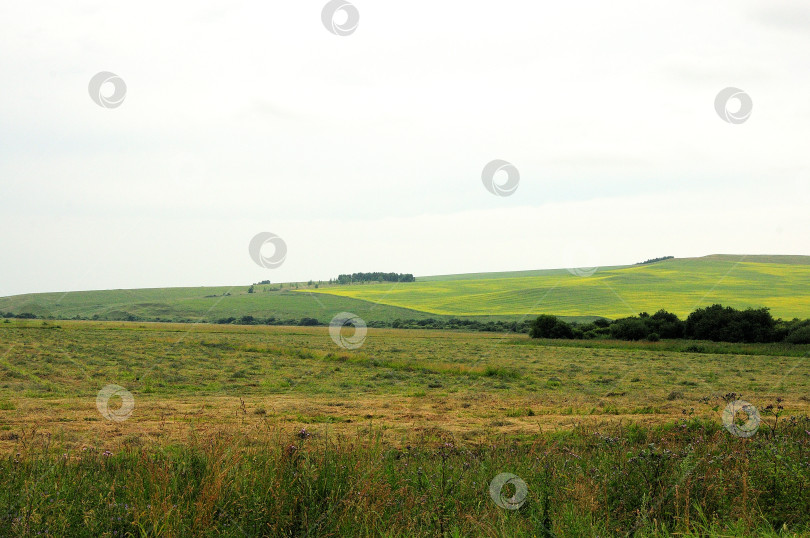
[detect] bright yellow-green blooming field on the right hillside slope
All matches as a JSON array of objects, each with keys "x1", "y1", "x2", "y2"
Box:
[{"x1": 316, "y1": 256, "x2": 810, "y2": 319}]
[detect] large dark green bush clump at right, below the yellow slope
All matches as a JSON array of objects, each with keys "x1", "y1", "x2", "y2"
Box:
[{"x1": 529, "y1": 304, "x2": 810, "y2": 344}]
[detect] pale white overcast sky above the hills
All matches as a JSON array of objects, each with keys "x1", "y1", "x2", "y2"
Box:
[{"x1": 0, "y1": 0, "x2": 810, "y2": 296}]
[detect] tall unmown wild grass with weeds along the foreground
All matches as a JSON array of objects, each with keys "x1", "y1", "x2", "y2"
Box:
[{"x1": 0, "y1": 417, "x2": 810, "y2": 537}]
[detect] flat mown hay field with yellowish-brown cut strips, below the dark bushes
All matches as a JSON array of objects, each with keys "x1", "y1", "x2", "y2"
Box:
[{"x1": 0, "y1": 320, "x2": 810, "y2": 452}]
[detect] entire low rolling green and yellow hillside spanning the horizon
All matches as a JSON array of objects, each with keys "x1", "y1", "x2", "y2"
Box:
[{"x1": 0, "y1": 255, "x2": 810, "y2": 323}]
